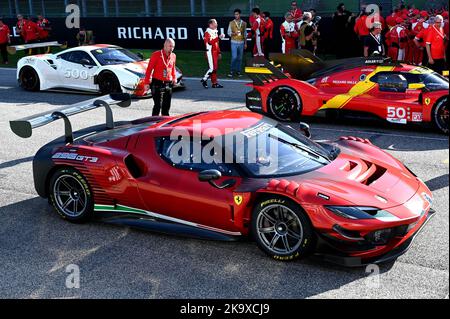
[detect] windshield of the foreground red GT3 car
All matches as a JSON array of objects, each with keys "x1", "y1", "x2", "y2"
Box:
[{"x1": 225, "y1": 119, "x2": 337, "y2": 177}]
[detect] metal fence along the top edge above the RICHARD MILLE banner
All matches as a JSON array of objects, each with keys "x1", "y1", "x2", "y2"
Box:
[{"x1": 0, "y1": 0, "x2": 448, "y2": 17}]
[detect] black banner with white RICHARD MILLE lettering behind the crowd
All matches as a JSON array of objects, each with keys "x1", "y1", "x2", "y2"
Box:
[{"x1": 4, "y1": 17, "x2": 333, "y2": 52}]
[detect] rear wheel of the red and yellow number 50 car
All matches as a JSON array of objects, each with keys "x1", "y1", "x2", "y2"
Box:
[{"x1": 267, "y1": 86, "x2": 302, "y2": 122}]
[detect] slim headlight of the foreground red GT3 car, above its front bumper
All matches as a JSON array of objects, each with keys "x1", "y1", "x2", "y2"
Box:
[{"x1": 325, "y1": 206, "x2": 398, "y2": 221}]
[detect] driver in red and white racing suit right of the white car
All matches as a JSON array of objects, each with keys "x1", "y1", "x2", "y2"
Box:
[{"x1": 200, "y1": 19, "x2": 224, "y2": 89}]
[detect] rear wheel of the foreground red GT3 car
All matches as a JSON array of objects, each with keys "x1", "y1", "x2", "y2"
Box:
[{"x1": 49, "y1": 167, "x2": 94, "y2": 223}]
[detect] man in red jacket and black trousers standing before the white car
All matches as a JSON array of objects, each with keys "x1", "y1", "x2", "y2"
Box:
[{"x1": 144, "y1": 38, "x2": 177, "y2": 116}]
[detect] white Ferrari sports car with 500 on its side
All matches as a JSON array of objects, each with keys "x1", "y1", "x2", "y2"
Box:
[{"x1": 17, "y1": 44, "x2": 184, "y2": 97}]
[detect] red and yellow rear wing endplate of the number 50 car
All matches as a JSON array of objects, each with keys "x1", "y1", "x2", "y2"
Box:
[{"x1": 245, "y1": 57, "x2": 288, "y2": 86}]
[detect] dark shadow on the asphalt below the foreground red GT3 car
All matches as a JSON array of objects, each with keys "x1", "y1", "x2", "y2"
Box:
[{"x1": 0, "y1": 197, "x2": 392, "y2": 298}]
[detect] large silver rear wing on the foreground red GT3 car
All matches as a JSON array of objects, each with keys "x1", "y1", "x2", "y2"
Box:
[{"x1": 9, "y1": 93, "x2": 131, "y2": 143}]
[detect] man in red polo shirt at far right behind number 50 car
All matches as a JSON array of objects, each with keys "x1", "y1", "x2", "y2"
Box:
[{"x1": 425, "y1": 15, "x2": 447, "y2": 74}]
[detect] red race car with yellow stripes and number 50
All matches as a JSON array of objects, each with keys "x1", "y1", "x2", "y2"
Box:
[{"x1": 246, "y1": 50, "x2": 449, "y2": 134}]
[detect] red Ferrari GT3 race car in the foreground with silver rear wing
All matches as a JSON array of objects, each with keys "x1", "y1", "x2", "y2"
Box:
[{"x1": 10, "y1": 94, "x2": 434, "y2": 266}]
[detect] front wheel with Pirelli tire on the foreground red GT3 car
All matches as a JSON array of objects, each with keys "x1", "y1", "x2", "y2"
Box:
[{"x1": 251, "y1": 195, "x2": 316, "y2": 261}]
